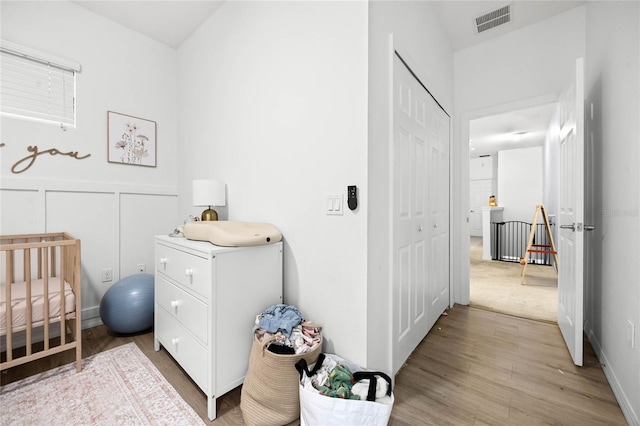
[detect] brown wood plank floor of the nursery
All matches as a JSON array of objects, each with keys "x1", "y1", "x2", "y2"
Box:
[{"x1": 1, "y1": 305, "x2": 626, "y2": 425}]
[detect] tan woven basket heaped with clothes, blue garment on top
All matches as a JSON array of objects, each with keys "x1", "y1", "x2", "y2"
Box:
[{"x1": 240, "y1": 304, "x2": 322, "y2": 425}]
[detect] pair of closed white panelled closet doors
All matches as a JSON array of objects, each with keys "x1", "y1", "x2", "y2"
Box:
[{"x1": 392, "y1": 55, "x2": 449, "y2": 374}]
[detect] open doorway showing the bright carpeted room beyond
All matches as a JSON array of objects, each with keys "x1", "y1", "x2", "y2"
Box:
[{"x1": 468, "y1": 101, "x2": 558, "y2": 322}]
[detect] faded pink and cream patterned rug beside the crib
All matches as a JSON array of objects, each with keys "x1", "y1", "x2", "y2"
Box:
[{"x1": 0, "y1": 343, "x2": 204, "y2": 425}]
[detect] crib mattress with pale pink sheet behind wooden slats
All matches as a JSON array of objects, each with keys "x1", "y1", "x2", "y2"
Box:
[{"x1": 0, "y1": 277, "x2": 76, "y2": 336}]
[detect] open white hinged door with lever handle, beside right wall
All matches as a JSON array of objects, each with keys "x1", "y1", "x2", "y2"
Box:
[{"x1": 557, "y1": 58, "x2": 584, "y2": 365}]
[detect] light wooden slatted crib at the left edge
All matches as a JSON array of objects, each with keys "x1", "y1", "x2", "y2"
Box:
[{"x1": 0, "y1": 233, "x2": 82, "y2": 372}]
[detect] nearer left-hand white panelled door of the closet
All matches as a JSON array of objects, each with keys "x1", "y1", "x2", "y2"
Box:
[{"x1": 393, "y1": 56, "x2": 428, "y2": 374}]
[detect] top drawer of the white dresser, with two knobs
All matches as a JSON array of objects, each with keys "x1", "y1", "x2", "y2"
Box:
[{"x1": 156, "y1": 244, "x2": 211, "y2": 299}]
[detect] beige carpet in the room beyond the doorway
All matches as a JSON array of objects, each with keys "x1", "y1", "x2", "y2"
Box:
[{"x1": 470, "y1": 237, "x2": 558, "y2": 322}]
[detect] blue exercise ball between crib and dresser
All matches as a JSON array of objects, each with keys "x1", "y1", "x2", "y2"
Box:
[{"x1": 100, "y1": 274, "x2": 155, "y2": 334}]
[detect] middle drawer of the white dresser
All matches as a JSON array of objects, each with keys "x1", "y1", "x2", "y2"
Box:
[{"x1": 156, "y1": 277, "x2": 208, "y2": 345}]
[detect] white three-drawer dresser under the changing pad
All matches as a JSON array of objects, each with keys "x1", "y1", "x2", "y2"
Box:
[{"x1": 154, "y1": 236, "x2": 282, "y2": 420}]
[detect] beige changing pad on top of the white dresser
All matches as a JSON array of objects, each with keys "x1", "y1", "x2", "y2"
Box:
[{"x1": 183, "y1": 220, "x2": 282, "y2": 247}]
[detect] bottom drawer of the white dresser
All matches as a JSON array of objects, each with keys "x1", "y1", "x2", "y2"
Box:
[{"x1": 155, "y1": 309, "x2": 212, "y2": 393}]
